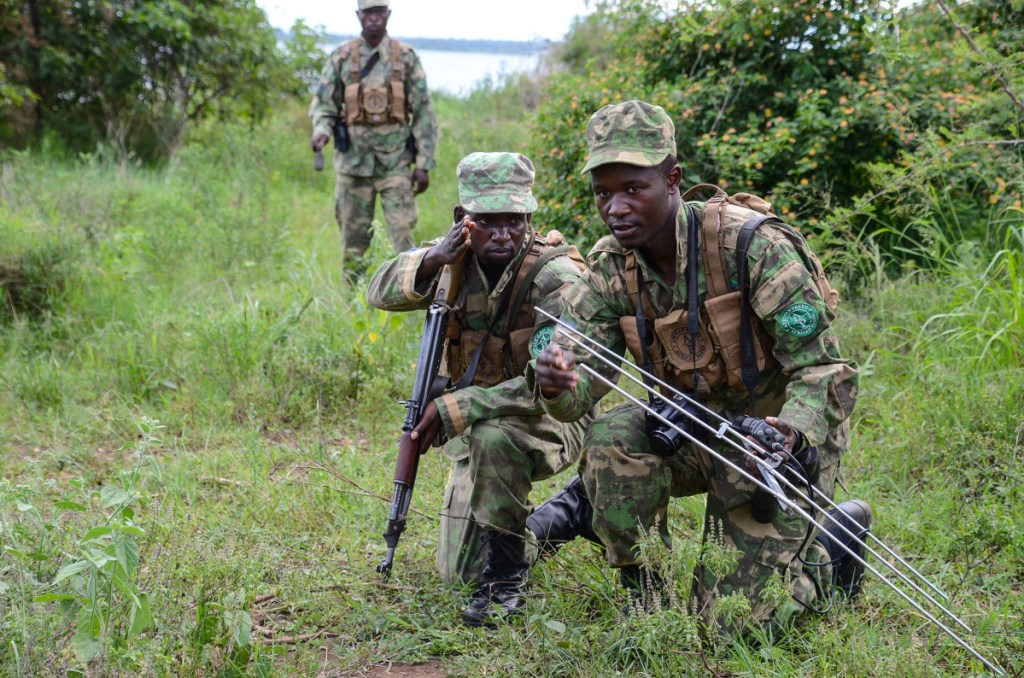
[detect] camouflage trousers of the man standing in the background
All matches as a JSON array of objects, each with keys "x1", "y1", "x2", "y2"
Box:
[{"x1": 334, "y1": 168, "x2": 418, "y2": 262}]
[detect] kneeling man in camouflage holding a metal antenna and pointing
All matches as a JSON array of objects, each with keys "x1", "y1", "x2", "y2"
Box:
[{"x1": 528, "y1": 101, "x2": 870, "y2": 634}]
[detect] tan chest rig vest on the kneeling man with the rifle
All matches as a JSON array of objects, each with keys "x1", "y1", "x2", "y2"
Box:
[{"x1": 447, "y1": 230, "x2": 585, "y2": 388}]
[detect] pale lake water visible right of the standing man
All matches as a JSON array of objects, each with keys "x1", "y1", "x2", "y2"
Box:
[{"x1": 416, "y1": 49, "x2": 541, "y2": 96}]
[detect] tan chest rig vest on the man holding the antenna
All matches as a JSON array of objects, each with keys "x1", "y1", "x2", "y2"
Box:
[{"x1": 618, "y1": 184, "x2": 839, "y2": 399}]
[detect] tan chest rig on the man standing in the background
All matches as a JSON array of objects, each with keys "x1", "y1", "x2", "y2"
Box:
[{"x1": 345, "y1": 38, "x2": 409, "y2": 125}]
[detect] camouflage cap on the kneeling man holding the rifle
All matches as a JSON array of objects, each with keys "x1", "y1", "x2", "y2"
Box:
[{"x1": 456, "y1": 153, "x2": 537, "y2": 214}]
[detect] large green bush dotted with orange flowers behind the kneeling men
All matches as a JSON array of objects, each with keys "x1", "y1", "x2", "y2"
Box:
[{"x1": 530, "y1": 0, "x2": 1024, "y2": 256}]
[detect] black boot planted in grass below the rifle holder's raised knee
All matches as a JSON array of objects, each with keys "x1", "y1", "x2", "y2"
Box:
[{"x1": 462, "y1": 531, "x2": 529, "y2": 626}]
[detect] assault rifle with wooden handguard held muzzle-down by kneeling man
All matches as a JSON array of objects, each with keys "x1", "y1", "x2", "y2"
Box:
[{"x1": 377, "y1": 259, "x2": 462, "y2": 579}]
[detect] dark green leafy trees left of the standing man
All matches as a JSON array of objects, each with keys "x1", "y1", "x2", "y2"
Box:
[{"x1": 0, "y1": 0, "x2": 308, "y2": 158}]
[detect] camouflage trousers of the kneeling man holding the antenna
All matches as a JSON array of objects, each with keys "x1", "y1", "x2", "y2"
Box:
[{"x1": 580, "y1": 404, "x2": 838, "y2": 635}]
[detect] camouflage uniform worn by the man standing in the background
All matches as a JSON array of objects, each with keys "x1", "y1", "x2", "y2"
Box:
[{"x1": 309, "y1": 6, "x2": 437, "y2": 261}]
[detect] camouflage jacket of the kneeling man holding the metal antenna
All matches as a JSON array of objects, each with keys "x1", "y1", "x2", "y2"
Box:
[{"x1": 529, "y1": 203, "x2": 858, "y2": 466}]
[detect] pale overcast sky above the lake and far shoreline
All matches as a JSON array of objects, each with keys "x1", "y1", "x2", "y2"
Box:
[{"x1": 256, "y1": 0, "x2": 590, "y2": 40}]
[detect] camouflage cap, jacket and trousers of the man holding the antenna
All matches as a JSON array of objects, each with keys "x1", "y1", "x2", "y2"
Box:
[{"x1": 529, "y1": 102, "x2": 857, "y2": 632}]
